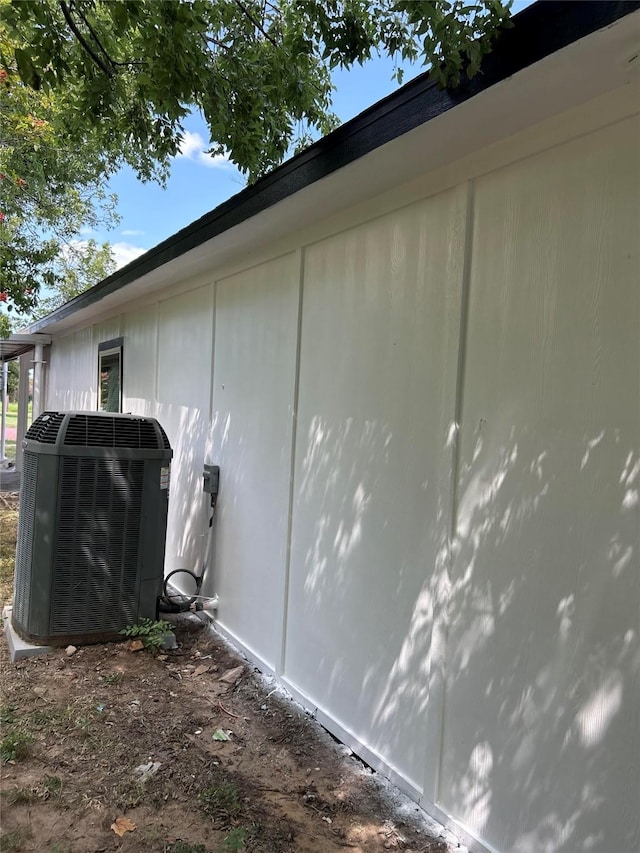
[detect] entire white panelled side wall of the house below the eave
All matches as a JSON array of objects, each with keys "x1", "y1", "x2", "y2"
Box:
[{"x1": 42, "y1": 106, "x2": 640, "y2": 853}]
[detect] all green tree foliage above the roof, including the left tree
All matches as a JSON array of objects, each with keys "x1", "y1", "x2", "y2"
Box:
[{"x1": 0, "y1": 0, "x2": 510, "y2": 332}]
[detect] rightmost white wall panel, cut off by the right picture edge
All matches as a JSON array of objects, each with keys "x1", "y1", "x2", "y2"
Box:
[{"x1": 440, "y1": 122, "x2": 640, "y2": 853}]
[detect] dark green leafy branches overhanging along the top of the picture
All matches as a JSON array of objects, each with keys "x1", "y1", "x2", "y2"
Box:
[{"x1": 0, "y1": 0, "x2": 509, "y2": 180}]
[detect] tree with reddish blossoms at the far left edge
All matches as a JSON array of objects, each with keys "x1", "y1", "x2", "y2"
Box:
[{"x1": 0, "y1": 20, "x2": 117, "y2": 334}]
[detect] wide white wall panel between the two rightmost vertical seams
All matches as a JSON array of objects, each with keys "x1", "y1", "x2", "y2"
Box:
[{"x1": 285, "y1": 188, "x2": 466, "y2": 788}]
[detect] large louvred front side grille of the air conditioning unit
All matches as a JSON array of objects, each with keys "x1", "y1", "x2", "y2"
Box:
[{"x1": 51, "y1": 457, "x2": 144, "y2": 636}]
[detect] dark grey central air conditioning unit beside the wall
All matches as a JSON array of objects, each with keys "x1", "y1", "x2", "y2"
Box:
[{"x1": 12, "y1": 412, "x2": 173, "y2": 645}]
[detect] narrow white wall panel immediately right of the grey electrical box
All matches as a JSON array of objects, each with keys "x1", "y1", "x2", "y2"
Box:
[{"x1": 211, "y1": 254, "x2": 300, "y2": 669}]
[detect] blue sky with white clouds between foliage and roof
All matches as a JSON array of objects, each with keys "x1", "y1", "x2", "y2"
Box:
[{"x1": 86, "y1": 0, "x2": 531, "y2": 266}]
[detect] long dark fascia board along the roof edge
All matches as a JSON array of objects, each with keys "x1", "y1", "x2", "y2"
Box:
[{"x1": 28, "y1": 0, "x2": 640, "y2": 333}]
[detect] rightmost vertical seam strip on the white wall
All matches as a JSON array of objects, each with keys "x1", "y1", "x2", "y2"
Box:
[{"x1": 432, "y1": 179, "x2": 475, "y2": 804}]
